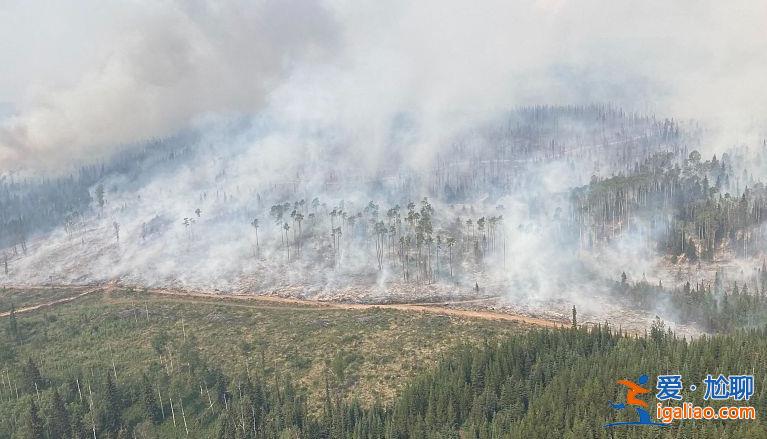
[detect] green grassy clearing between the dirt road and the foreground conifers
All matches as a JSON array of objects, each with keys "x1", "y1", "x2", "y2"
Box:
[{"x1": 0, "y1": 290, "x2": 524, "y2": 410}]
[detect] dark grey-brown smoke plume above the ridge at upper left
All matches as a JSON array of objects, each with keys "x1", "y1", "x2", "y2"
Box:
[{"x1": 0, "y1": 0, "x2": 337, "y2": 167}]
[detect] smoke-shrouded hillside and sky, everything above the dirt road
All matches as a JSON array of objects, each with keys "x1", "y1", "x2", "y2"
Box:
[{"x1": 0, "y1": 0, "x2": 767, "y2": 336}]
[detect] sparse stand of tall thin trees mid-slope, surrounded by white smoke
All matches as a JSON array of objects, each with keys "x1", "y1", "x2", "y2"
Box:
[{"x1": 260, "y1": 197, "x2": 506, "y2": 283}]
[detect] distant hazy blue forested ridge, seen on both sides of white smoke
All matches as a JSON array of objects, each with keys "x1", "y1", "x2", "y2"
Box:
[{"x1": 0, "y1": 105, "x2": 683, "y2": 256}]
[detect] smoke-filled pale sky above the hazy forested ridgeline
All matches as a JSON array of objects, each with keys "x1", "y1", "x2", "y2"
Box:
[{"x1": 0, "y1": 0, "x2": 767, "y2": 169}]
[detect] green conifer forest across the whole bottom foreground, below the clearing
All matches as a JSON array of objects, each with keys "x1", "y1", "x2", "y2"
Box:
[{"x1": 0, "y1": 320, "x2": 767, "y2": 439}]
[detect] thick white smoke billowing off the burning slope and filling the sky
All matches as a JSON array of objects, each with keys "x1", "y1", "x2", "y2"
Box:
[{"x1": 0, "y1": 0, "x2": 767, "y2": 336}]
